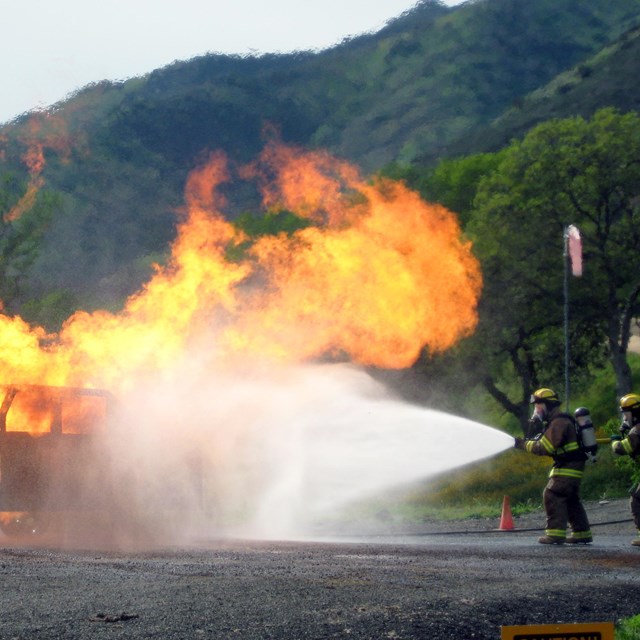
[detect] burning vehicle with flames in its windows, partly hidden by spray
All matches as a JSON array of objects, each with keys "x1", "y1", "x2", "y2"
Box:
[{"x1": 0, "y1": 384, "x2": 114, "y2": 535}]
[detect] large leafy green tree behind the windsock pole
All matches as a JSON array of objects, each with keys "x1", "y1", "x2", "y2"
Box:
[{"x1": 467, "y1": 109, "x2": 640, "y2": 423}]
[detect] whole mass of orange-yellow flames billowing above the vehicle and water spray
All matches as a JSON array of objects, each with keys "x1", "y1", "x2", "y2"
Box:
[{"x1": 0, "y1": 143, "x2": 482, "y2": 395}]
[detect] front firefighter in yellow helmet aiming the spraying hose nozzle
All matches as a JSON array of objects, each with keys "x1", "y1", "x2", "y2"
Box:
[{"x1": 514, "y1": 388, "x2": 593, "y2": 544}]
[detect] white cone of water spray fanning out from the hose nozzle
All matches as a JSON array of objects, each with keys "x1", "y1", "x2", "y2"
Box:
[{"x1": 95, "y1": 358, "x2": 510, "y2": 543}]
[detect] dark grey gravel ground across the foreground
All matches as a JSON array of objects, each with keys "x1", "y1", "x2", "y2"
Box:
[{"x1": 0, "y1": 500, "x2": 640, "y2": 640}]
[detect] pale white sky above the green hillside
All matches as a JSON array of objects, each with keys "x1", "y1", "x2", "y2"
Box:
[{"x1": 0, "y1": 0, "x2": 462, "y2": 123}]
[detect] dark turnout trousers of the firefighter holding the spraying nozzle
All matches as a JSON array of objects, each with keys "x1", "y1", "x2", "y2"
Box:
[{"x1": 542, "y1": 476, "x2": 592, "y2": 538}]
